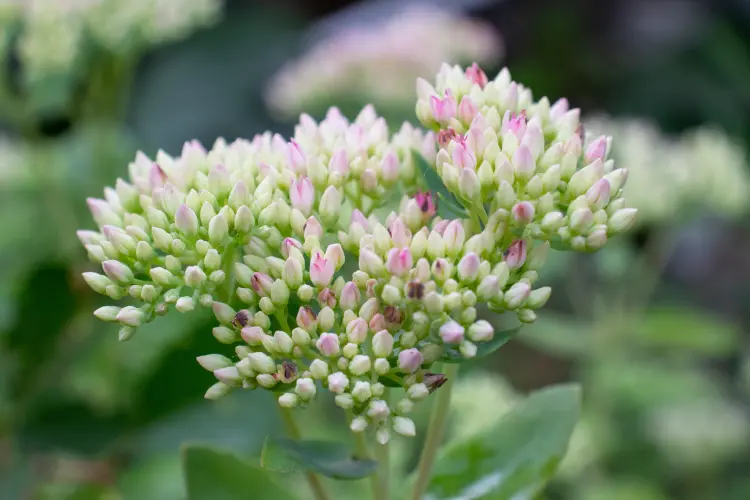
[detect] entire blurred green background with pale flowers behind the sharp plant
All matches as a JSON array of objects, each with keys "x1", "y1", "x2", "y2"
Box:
[{"x1": 0, "y1": 0, "x2": 750, "y2": 500}]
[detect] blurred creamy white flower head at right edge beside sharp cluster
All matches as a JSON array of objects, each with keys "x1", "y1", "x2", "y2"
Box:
[{"x1": 586, "y1": 117, "x2": 750, "y2": 223}]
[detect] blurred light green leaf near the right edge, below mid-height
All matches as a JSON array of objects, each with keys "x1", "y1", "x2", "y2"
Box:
[{"x1": 632, "y1": 307, "x2": 739, "y2": 356}]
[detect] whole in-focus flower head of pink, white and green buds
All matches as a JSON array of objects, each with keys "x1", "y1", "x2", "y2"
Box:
[{"x1": 79, "y1": 62, "x2": 634, "y2": 443}]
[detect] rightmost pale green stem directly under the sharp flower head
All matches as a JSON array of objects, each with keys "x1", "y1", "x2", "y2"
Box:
[{"x1": 412, "y1": 363, "x2": 458, "y2": 500}]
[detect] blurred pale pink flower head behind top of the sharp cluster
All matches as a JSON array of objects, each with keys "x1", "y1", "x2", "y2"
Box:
[{"x1": 266, "y1": 6, "x2": 503, "y2": 117}]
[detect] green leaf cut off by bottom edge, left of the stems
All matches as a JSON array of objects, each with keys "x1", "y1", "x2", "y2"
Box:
[{"x1": 182, "y1": 445, "x2": 291, "y2": 500}]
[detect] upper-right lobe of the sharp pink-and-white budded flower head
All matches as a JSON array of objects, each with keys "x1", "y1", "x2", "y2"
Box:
[{"x1": 416, "y1": 65, "x2": 636, "y2": 255}]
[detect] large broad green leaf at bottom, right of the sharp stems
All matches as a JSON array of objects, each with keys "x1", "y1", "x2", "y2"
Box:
[{"x1": 425, "y1": 384, "x2": 581, "y2": 500}]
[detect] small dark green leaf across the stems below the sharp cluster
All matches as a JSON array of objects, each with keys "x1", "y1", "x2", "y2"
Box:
[{"x1": 260, "y1": 436, "x2": 377, "y2": 479}]
